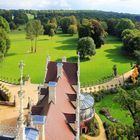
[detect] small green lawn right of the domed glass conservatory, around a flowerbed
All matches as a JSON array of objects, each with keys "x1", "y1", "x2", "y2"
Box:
[{"x1": 95, "y1": 95, "x2": 133, "y2": 125}]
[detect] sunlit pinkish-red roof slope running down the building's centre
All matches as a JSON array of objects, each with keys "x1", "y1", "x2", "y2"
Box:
[{"x1": 46, "y1": 72, "x2": 76, "y2": 140}]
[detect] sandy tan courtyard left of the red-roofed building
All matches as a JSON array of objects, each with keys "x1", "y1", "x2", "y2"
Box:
[{"x1": 0, "y1": 82, "x2": 38, "y2": 126}]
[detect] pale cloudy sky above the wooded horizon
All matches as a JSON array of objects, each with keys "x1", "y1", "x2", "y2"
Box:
[{"x1": 0, "y1": 0, "x2": 140, "y2": 14}]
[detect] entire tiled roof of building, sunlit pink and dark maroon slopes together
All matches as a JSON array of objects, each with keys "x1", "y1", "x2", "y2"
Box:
[{"x1": 32, "y1": 62, "x2": 77, "y2": 140}]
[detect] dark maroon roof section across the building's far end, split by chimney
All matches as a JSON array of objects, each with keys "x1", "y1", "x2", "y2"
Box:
[{"x1": 46, "y1": 61, "x2": 77, "y2": 85}]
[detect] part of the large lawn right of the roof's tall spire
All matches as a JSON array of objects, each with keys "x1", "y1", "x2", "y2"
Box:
[{"x1": 81, "y1": 36, "x2": 130, "y2": 83}]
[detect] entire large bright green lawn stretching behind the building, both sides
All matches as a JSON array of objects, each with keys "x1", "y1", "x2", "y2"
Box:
[{"x1": 0, "y1": 31, "x2": 130, "y2": 83}]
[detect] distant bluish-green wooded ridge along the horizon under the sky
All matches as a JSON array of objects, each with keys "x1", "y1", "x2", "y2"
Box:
[{"x1": 32, "y1": 10, "x2": 140, "y2": 21}]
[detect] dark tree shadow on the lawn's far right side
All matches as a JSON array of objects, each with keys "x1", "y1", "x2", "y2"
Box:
[{"x1": 105, "y1": 45, "x2": 130, "y2": 63}]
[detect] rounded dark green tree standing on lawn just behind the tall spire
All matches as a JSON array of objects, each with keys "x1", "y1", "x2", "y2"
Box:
[{"x1": 77, "y1": 37, "x2": 96, "y2": 59}]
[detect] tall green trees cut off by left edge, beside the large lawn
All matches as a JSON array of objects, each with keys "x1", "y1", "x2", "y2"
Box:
[{"x1": 0, "y1": 16, "x2": 10, "y2": 59}]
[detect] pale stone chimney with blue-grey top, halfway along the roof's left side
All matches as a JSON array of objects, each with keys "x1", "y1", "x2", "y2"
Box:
[{"x1": 48, "y1": 82, "x2": 57, "y2": 104}]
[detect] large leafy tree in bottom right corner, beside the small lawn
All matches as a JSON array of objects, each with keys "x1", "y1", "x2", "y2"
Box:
[{"x1": 115, "y1": 89, "x2": 140, "y2": 140}]
